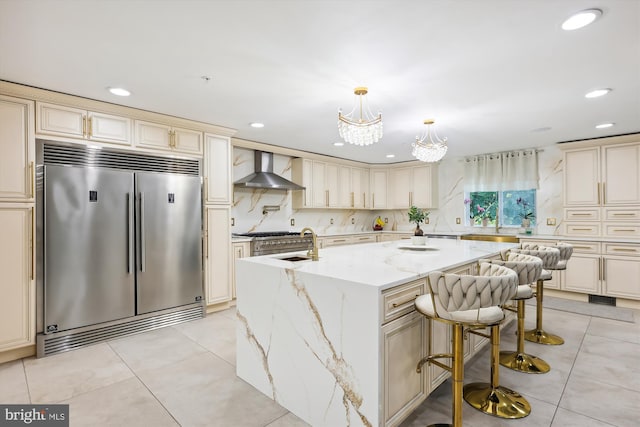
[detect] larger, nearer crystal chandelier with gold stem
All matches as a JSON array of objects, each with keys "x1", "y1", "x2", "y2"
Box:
[{"x1": 338, "y1": 87, "x2": 382, "y2": 145}]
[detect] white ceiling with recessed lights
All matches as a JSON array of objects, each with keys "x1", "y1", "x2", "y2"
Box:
[{"x1": 0, "y1": 0, "x2": 640, "y2": 163}]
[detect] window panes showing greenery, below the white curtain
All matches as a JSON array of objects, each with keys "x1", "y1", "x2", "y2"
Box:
[{"x1": 465, "y1": 190, "x2": 536, "y2": 227}]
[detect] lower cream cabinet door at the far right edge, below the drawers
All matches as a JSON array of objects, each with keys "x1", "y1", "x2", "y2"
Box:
[{"x1": 602, "y1": 256, "x2": 640, "y2": 299}]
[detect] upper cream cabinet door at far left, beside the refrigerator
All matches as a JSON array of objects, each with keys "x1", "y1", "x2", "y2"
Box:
[{"x1": 0, "y1": 96, "x2": 35, "y2": 201}]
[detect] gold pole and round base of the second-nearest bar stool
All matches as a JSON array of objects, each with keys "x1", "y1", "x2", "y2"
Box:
[{"x1": 464, "y1": 325, "x2": 531, "y2": 419}]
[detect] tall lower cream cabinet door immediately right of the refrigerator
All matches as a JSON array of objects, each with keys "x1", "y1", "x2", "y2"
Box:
[{"x1": 205, "y1": 207, "x2": 232, "y2": 304}]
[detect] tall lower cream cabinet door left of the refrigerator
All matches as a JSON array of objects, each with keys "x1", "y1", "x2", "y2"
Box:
[{"x1": 0, "y1": 204, "x2": 36, "y2": 351}]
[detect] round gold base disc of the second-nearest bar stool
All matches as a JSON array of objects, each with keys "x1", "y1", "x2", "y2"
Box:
[{"x1": 463, "y1": 383, "x2": 531, "y2": 419}]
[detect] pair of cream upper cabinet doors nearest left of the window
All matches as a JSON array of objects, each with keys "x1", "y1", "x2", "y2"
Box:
[{"x1": 389, "y1": 165, "x2": 437, "y2": 209}]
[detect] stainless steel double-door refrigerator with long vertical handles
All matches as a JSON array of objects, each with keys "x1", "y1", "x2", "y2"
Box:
[{"x1": 43, "y1": 164, "x2": 202, "y2": 334}]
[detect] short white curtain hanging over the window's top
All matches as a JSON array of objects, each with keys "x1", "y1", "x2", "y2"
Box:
[{"x1": 464, "y1": 150, "x2": 538, "y2": 192}]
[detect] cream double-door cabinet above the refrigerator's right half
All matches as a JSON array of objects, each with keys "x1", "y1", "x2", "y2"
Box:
[{"x1": 135, "y1": 120, "x2": 203, "y2": 155}]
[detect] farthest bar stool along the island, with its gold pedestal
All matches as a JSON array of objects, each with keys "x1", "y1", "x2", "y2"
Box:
[{"x1": 511, "y1": 243, "x2": 566, "y2": 345}]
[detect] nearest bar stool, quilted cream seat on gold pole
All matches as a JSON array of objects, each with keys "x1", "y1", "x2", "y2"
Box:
[{"x1": 415, "y1": 263, "x2": 518, "y2": 427}]
